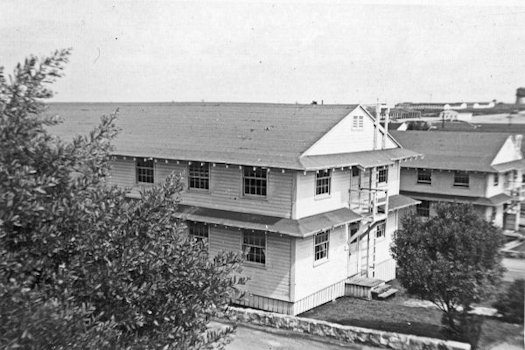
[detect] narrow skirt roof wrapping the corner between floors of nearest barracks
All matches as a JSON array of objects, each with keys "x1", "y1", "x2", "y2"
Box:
[{"x1": 174, "y1": 205, "x2": 362, "y2": 238}]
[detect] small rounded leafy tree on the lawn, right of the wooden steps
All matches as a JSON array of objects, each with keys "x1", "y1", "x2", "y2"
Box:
[{"x1": 391, "y1": 203, "x2": 503, "y2": 333}]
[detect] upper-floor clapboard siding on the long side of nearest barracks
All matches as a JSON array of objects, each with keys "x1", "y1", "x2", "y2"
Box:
[{"x1": 111, "y1": 159, "x2": 294, "y2": 218}]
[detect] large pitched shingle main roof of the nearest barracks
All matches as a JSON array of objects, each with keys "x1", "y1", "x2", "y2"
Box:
[{"x1": 46, "y1": 103, "x2": 416, "y2": 170}]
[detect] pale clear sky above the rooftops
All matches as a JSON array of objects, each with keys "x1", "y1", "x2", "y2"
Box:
[{"x1": 0, "y1": 0, "x2": 525, "y2": 104}]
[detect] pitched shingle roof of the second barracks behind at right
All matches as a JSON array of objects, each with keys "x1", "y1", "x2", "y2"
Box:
[{"x1": 391, "y1": 131, "x2": 509, "y2": 172}]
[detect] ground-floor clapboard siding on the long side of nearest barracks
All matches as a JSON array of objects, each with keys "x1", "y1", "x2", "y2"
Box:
[{"x1": 209, "y1": 226, "x2": 291, "y2": 301}]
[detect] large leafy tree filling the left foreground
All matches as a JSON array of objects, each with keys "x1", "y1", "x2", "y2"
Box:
[{"x1": 0, "y1": 50, "x2": 244, "y2": 349}]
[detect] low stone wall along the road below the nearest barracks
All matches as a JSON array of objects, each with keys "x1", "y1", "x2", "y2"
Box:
[{"x1": 223, "y1": 307, "x2": 470, "y2": 350}]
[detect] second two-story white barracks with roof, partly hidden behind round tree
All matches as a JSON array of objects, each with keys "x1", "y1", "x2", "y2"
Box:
[{"x1": 392, "y1": 131, "x2": 525, "y2": 230}]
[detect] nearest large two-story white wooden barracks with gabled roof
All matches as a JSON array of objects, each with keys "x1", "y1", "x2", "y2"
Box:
[{"x1": 49, "y1": 103, "x2": 419, "y2": 315}]
